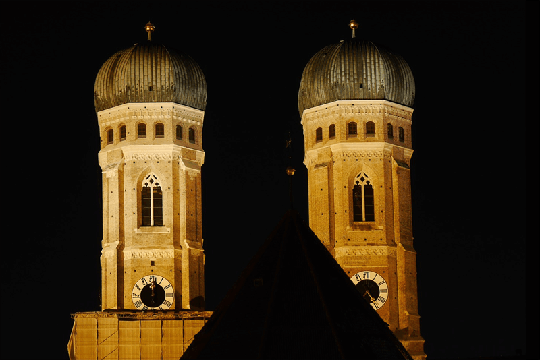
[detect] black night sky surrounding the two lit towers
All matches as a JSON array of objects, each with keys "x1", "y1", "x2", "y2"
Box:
[{"x1": 0, "y1": 1, "x2": 538, "y2": 359}]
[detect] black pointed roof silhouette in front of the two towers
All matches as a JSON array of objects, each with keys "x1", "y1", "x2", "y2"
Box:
[{"x1": 182, "y1": 210, "x2": 410, "y2": 359}]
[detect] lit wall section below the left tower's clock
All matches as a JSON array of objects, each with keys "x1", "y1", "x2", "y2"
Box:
[{"x1": 67, "y1": 311, "x2": 212, "y2": 360}]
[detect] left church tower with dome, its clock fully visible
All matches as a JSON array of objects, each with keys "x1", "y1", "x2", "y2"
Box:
[{"x1": 94, "y1": 24, "x2": 206, "y2": 310}]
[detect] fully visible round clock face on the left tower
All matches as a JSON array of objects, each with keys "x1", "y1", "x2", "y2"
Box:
[{"x1": 131, "y1": 275, "x2": 174, "y2": 310}]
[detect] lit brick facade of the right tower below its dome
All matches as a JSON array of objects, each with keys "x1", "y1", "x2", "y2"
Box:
[{"x1": 302, "y1": 100, "x2": 425, "y2": 359}]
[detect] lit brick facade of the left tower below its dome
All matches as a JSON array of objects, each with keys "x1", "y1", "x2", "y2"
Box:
[{"x1": 98, "y1": 103, "x2": 205, "y2": 310}]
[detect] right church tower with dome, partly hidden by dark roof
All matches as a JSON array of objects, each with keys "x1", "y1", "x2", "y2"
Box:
[{"x1": 298, "y1": 21, "x2": 425, "y2": 359}]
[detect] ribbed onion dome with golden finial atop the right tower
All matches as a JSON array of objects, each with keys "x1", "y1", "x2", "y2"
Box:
[{"x1": 298, "y1": 28, "x2": 415, "y2": 114}]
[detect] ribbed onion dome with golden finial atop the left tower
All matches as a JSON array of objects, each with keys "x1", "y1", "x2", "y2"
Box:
[{"x1": 94, "y1": 24, "x2": 206, "y2": 111}]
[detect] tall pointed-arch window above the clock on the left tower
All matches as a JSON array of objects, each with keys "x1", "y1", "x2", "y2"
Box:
[{"x1": 141, "y1": 174, "x2": 163, "y2": 226}]
